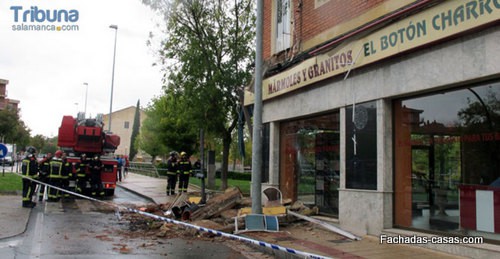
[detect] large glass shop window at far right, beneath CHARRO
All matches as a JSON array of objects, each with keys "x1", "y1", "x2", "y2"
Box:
[{"x1": 394, "y1": 83, "x2": 500, "y2": 242}]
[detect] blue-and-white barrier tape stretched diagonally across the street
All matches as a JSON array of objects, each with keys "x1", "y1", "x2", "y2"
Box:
[{"x1": 14, "y1": 172, "x2": 331, "y2": 259}]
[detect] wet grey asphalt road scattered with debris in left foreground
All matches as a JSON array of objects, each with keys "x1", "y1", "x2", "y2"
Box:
[{"x1": 0, "y1": 188, "x2": 260, "y2": 259}]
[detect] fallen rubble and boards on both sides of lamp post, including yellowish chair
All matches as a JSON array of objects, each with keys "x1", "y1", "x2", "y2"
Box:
[{"x1": 114, "y1": 188, "x2": 348, "y2": 254}]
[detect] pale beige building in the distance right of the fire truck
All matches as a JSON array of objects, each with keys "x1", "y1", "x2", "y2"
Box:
[{"x1": 103, "y1": 106, "x2": 146, "y2": 156}]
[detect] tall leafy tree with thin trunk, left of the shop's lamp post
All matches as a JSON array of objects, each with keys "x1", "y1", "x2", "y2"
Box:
[{"x1": 143, "y1": 0, "x2": 255, "y2": 189}]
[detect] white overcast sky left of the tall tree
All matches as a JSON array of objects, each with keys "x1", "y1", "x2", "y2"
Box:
[{"x1": 0, "y1": 0, "x2": 161, "y2": 137}]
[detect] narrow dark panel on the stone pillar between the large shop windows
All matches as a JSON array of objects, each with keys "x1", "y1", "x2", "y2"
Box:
[{"x1": 345, "y1": 102, "x2": 377, "y2": 190}]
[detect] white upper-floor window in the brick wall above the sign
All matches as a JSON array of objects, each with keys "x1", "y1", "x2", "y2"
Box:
[{"x1": 275, "y1": 0, "x2": 291, "y2": 52}]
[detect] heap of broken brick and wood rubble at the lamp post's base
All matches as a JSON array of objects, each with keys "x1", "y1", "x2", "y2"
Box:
[{"x1": 117, "y1": 188, "x2": 317, "y2": 242}]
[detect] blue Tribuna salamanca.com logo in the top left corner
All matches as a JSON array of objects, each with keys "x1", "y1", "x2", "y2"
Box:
[{"x1": 10, "y1": 6, "x2": 80, "y2": 31}]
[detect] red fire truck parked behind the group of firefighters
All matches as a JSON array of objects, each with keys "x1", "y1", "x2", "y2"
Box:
[{"x1": 57, "y1": 113, "x2": 120, "y2": 196}]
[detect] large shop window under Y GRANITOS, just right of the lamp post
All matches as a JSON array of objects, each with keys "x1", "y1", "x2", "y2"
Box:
[{"x1": 280, "y1": 112, "x2": 340, "y2": 215}]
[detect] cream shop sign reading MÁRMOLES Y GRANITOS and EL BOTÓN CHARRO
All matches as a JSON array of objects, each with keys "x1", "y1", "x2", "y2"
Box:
[{"x1": 245, "y1": 0, "x2": 500, "y2": 105}]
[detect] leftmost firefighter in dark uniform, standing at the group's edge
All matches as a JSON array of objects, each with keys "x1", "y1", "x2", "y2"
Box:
[{"x1": 21, "y1": 147, "x2": 38, "y2": 208}]
